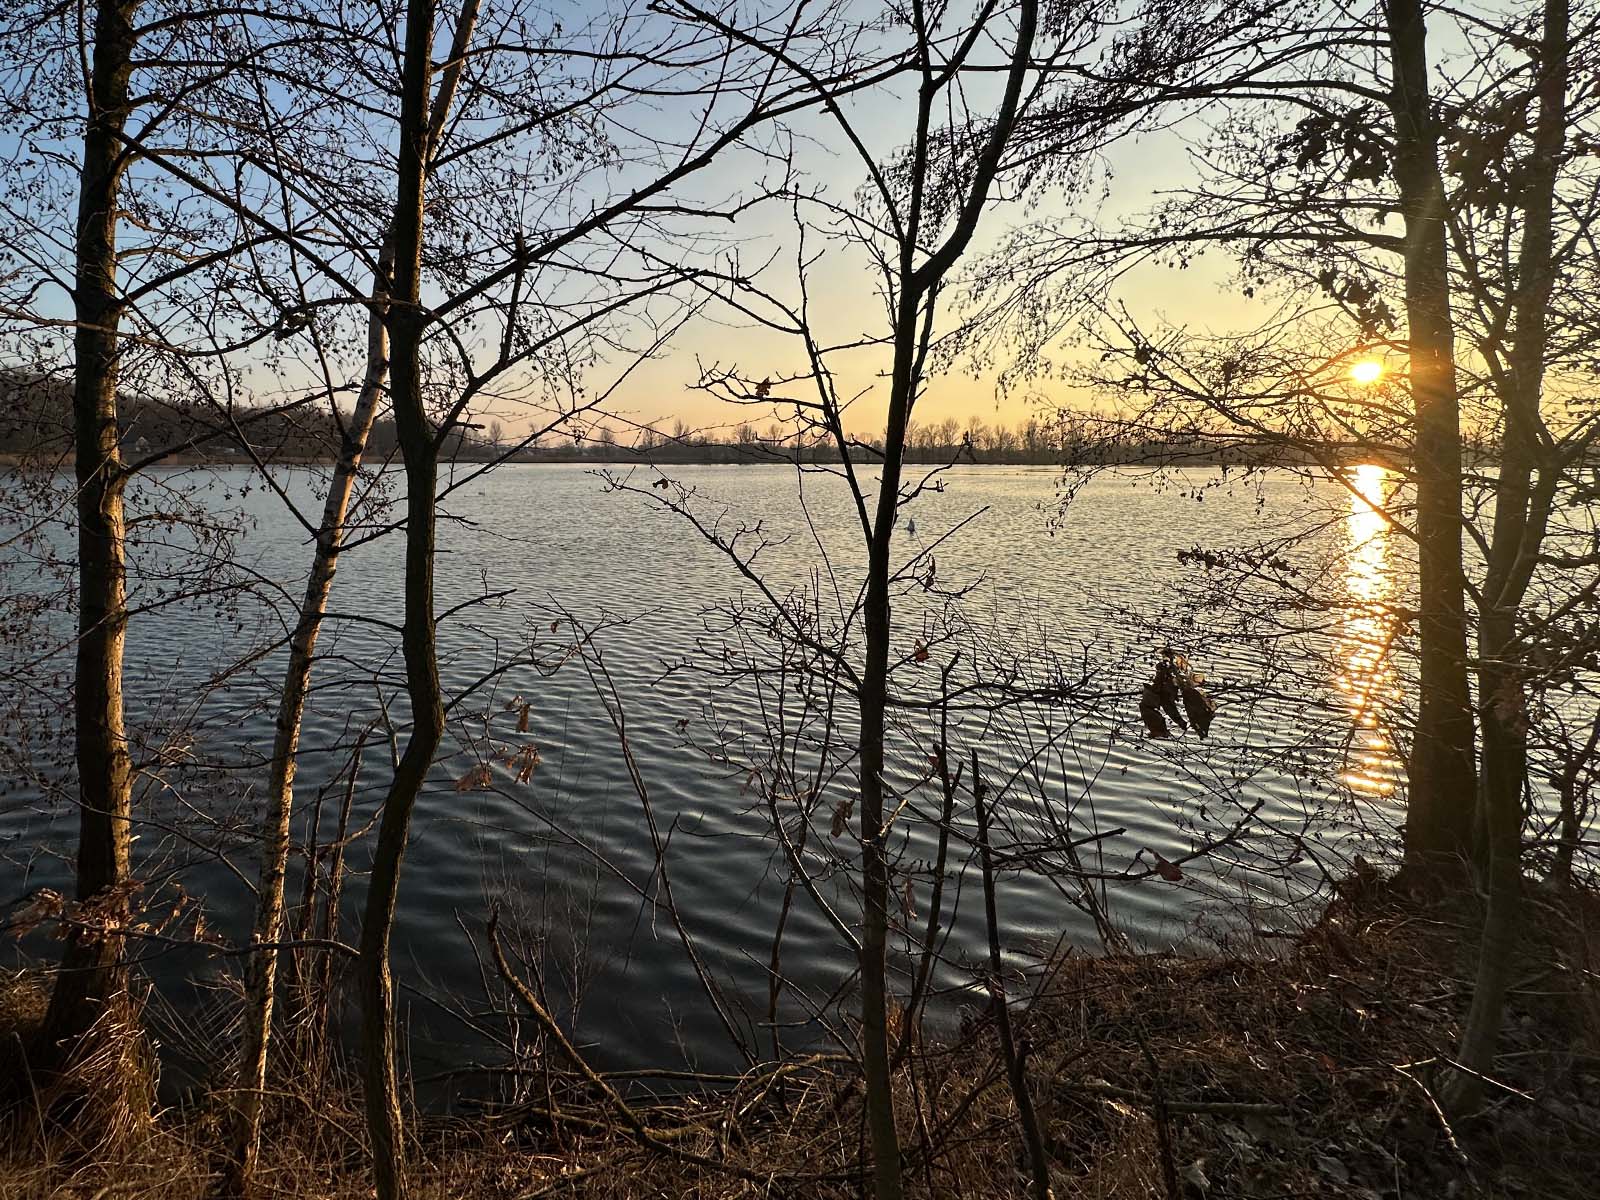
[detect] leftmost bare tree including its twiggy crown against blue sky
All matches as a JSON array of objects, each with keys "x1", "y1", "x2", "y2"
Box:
[{"x1": 5, "y1": 3, "x2": 350, "y2": 1051}]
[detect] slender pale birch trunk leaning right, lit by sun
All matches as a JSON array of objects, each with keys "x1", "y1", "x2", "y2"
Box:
[{"x1": 227, "y1": 242, "x2": 394, "y2": 1192}]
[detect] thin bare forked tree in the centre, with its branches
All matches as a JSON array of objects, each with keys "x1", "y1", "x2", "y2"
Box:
[{"x1": 614, "y1": 0, "x2": 1254, "y2": 1197}]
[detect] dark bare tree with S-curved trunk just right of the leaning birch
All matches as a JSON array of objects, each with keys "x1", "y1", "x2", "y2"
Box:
[{"x1": 224, "y1": 0, "x2": 883, "y2": 1197}]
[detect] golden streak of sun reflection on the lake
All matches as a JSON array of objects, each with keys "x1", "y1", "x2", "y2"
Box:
[{"x1": 1338, "y1": 466, "x2": 1400, "y2": 797}]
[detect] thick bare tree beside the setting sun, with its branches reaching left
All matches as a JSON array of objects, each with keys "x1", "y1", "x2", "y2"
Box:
[{"x1": 978, "y1": 0, "x2": 1475, "y2": 875}]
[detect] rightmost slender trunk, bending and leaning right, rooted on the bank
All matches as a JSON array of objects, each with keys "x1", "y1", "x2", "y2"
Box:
[{"x1": 1445, "y1": 0, "x2": 1570, "y2": 1114}]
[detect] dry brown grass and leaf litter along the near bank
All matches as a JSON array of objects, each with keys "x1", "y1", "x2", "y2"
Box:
[{"x1": 0, "y1": 877, "x2": 1600, "y2": 1200}]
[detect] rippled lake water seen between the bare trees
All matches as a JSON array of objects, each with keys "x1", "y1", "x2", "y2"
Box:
[{"x1": 0, "y1": 466, "x2": 1410, "y2": 1075}]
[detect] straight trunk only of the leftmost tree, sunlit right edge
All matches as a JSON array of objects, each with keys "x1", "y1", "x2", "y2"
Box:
[{"x1": 45, "y1": 2, "x2": 138, "y2": 1056}]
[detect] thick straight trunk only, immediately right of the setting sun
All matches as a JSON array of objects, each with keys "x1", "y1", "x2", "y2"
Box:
[{"x1": 1387, "y1": 0, "x2": 1475, "y2": 874}]
